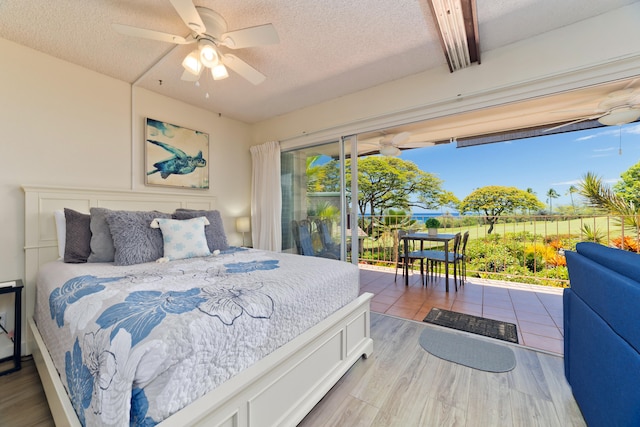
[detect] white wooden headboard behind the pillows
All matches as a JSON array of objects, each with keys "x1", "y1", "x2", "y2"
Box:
[{"x1": 22, "y1": 185, "x2": 216, "y2": 354}]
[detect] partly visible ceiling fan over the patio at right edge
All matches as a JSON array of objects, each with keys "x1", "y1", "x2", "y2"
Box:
[{"x1": 545, "y1": 88, "x2": 640, "y2": 132}]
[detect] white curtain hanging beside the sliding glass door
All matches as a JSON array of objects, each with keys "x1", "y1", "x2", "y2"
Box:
[{"x1": 251, "y1": 141, "x2": 282, "y2": 252}]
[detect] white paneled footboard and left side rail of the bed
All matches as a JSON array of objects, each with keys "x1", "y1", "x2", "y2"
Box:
[{"x1": 29, "y1": 293, "x2": 373, "y2": 427}]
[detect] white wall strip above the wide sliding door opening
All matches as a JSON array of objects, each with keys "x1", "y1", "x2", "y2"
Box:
[{"x1": 253, "y1": 3, "x2": 640, "y2": 148}]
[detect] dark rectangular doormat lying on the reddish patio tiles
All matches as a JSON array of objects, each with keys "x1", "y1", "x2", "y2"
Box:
[{"x1": 424, "y1": 308, "x2": 518, "y2": 344}]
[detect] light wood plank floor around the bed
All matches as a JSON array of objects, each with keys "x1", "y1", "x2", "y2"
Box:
[{"x1": 0, "y1": 313, "x2": 585, "y2": 427}]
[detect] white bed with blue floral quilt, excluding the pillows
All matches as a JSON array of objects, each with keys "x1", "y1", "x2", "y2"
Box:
[{"x1": 23, "y1": 186, "x2": 373, "y2": 426}]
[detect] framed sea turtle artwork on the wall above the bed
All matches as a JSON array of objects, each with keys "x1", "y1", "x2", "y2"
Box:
[{"x1": 144, "y1": 118, "x2": 209, "y2": 189}]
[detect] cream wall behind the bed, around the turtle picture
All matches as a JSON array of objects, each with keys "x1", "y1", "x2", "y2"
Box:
[{"x1": 0, "y1": 39, "x2": 251, "y2": 356}]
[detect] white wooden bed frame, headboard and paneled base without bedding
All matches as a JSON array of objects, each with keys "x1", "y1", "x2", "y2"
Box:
[{"x1": 22, "y1": 186, "x2": 373, "y2": 427}]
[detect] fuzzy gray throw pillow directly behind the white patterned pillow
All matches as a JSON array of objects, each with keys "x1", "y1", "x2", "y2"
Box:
[{"x1": 107, "y1": 211, "x2": 171, "y2": 265}]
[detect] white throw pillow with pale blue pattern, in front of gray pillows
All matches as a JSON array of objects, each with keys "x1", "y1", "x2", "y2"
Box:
[{"x1": 151, "y1": 216, "x2": 211, "y2": 260}]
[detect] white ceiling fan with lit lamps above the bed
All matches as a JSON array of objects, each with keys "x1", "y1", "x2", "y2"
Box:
[{"x1": 111, "y1": 0, "x2": 280, "y2": 85}]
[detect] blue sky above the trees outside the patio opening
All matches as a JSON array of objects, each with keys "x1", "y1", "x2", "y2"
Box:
[{"x1": 400, "y1": 123, "x2": 640, "y2": 211}]
